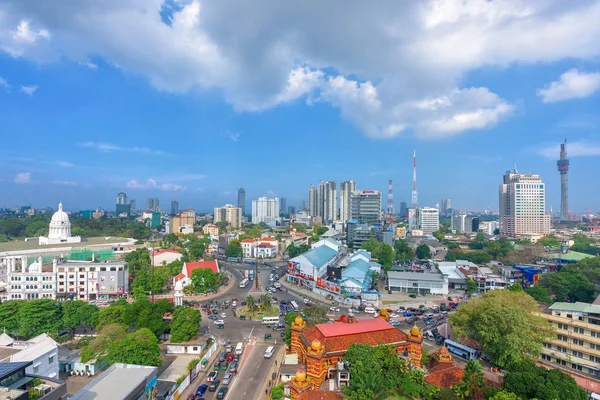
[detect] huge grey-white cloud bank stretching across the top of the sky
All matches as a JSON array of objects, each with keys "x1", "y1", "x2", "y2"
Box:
[{"x1": 0, "y1": 0, "x2": 600, "y2": 138}]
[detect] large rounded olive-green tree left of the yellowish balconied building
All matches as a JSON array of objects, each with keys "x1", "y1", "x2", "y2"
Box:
[{"x1": 450, "y1": 290, "x2": 555, "y2": 367}]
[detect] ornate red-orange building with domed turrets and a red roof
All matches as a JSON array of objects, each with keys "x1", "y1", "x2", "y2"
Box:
[{"x1": 287, "y1": 315, "x2": 423, "y2": 400}]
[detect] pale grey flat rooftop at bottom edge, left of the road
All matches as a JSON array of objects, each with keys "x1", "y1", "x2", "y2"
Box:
[{"x1": 69, "y1": 364, "x2": 158, "y2": 400}]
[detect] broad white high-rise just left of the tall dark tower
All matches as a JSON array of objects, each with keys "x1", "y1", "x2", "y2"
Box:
[{"x1": 499, "y1": 166, "x2": 550, "y2": 237}]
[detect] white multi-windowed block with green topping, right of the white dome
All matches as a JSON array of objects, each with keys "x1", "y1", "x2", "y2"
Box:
[{"x1": 56, "y1": 261, "x2": 129, "y2": 300}]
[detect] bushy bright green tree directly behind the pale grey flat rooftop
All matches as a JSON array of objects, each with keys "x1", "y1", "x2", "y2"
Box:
[{"x1": 108, "y1": 328, "x2": 162, "y2": 367}]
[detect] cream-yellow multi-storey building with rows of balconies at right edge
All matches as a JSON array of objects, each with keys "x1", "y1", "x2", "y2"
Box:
[{"x1": 540, "y1": 302, "x2": 600, "y2": 377}]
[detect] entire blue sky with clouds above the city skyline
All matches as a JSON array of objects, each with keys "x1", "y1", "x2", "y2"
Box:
[{"x1": 0, "y1": 0, "x2": 600, "y2": 212}]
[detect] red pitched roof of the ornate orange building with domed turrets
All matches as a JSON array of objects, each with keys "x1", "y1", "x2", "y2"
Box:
[{"x1": 303, "y1": 318, "x2": 407, "y2": 352}]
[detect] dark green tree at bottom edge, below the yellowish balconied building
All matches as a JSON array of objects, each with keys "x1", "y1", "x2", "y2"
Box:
[{"x1": 503, "y1": 359, "x2": 588, "y2": 400}]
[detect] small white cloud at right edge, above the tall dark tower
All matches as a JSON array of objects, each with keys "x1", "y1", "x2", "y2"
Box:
[{"x1": 538, "y1": 68, "x2": 600, "y2": 103}]
